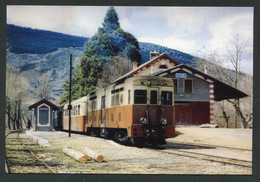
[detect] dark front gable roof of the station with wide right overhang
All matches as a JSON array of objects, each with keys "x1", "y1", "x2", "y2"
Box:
[{"x1": 153, "y1": 64, "x2": 248, "y2": 101}]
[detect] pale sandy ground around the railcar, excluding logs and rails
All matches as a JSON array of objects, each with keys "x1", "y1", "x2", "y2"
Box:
[{"x1": 6, "y1": 127, "x2": 252, "y2": 174}]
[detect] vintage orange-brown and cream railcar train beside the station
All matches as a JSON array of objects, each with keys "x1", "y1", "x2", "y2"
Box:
[{"x1": 63, "y1": 76, "x2": 175, "y2": 145}]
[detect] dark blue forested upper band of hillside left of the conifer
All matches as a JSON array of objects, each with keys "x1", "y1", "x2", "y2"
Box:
[{"x1": 6, "y1": 25, "x2": 88, "y2": 54}]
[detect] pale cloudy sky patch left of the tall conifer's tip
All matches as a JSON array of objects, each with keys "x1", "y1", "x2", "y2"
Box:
[{"x1": 7, "y1": 6, "x2": 108, "y2": 37}]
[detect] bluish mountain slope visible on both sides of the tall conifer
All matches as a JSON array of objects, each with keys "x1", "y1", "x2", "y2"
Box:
[{"x1": 6, "y1": 25, "x2": 196, "y2": 100}]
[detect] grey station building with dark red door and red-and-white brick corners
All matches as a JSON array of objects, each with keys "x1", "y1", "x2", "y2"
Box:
[{"x1": 113, "y1": 51, "x2": 247, "y2": 125}]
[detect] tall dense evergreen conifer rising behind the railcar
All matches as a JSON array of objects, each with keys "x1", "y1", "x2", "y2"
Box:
[{"x1": 60, "y1": 7, "x2": 141, "y2": 104}]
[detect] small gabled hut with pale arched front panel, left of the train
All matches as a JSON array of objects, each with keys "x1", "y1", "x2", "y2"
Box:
[{"x1": 29, "y1": 98, "x2": 60, "y2": 131}]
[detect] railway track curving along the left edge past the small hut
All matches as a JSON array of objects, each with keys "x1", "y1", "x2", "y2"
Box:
[{"x1": 5, "y1": 130, "x2": 57, "y2": 173}]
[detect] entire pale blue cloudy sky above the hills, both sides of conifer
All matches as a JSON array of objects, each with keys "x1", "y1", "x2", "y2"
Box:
[{"x1": 7, "y1": 6, "x2": 254, "y2": 73}]
